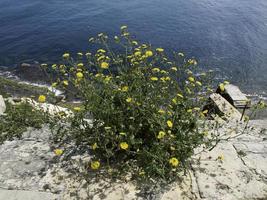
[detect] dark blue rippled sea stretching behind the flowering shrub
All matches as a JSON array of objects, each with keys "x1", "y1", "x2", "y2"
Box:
[{"x1": 0, "y1": 0, "x2": 267, "y2": 93}]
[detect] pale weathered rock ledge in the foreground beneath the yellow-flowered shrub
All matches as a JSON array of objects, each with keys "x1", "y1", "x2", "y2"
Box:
[{"x1": 0, "y1": 120, "x2": 267, "y2": 200}]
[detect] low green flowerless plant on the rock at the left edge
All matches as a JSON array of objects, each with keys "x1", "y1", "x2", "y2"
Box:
[{"x1": 0, "y1": 102, "x2": 48, "y2": 144}]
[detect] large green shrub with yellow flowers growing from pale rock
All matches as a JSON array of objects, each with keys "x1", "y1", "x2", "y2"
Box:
[{"x1": 47, "y1": 26, "x2": 217, "y2": 179}]
